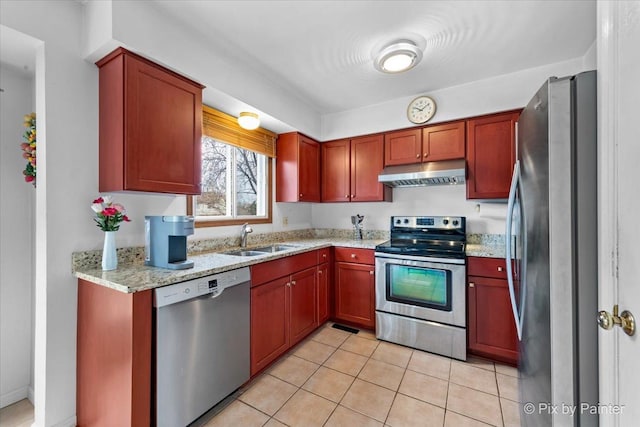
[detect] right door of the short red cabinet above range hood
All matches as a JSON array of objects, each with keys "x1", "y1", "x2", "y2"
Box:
[{"x1": 422, "y1": 121, "x2": 465, "y2": 162}]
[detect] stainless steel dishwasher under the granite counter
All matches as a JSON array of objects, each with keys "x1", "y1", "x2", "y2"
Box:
[{"x1": 153, "y1": 268, "x2": 251, "y2": 427}]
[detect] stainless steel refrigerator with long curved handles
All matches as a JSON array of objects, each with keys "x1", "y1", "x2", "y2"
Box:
[{"x1": 505, "y1": 71, "x2": 598, "y2": 427}]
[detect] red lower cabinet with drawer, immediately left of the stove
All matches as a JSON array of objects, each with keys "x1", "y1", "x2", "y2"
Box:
[{"x1": 335, "y1": 248, "x2": 376, "y2": 329}]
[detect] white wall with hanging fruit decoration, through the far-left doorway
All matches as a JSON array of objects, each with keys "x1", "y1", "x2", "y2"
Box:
[{"x1": 0, "y1": 63, "x2": 35, "y2": 407}]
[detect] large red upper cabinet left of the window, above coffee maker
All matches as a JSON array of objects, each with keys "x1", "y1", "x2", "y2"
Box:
[{"x1": 96, "y1": 48, "x2": 204, "y2": 194}]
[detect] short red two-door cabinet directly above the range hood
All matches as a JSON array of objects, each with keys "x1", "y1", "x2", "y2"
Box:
[{"x1": 384, "y1": 120, "x2": 465, "y2": 166}]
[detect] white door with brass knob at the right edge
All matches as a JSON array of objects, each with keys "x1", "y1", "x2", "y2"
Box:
[{"x1": 594, "y1": 0, "x2": 640, "y2": 427}]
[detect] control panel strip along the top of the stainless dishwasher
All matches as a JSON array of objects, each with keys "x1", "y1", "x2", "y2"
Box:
[{"x1": 153, "y1": 267, "x2": 251, "y2": 308}]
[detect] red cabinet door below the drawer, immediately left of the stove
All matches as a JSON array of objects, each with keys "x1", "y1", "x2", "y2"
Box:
[{"x1": 335, "y1": 262, "x2": 375, "y2": 329}]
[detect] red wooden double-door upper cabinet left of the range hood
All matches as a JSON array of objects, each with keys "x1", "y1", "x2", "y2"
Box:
[{"x1": 322, "y1": 134, "x2": 391, "y2": 202}]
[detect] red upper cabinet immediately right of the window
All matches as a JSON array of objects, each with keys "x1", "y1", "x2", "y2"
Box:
[{"x1": 276, "y1": 132, "x2": 320, "y2": 202}]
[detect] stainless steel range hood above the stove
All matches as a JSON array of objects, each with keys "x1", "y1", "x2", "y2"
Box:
[{"x1": 378, "y1": 159, "x2": 466, "y2": 187}]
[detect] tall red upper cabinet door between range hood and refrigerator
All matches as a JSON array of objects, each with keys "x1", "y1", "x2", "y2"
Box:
[{"x1": 467, "y1": 111, "x2": 520, "y2": 199}]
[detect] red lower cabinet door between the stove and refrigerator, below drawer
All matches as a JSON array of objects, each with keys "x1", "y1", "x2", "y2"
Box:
[{"x1": 468, "y1": 276, "x2": 518, "y2": 365}]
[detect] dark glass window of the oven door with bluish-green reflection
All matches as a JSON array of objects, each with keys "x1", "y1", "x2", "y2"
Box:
[{"x1": 387, "y1": 264, "x2": 451, "y2": 311}]
